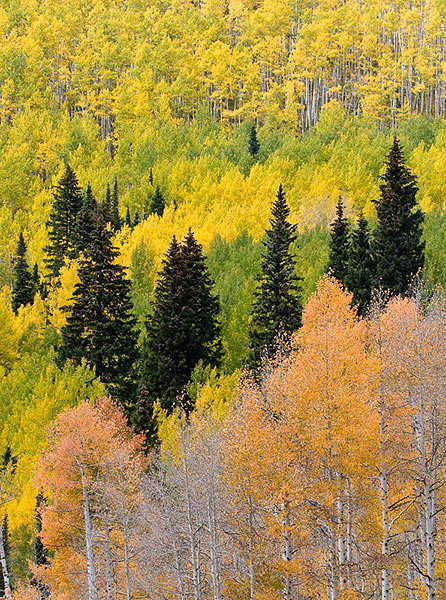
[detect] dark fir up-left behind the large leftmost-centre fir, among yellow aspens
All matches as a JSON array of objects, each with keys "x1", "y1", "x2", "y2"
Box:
[{"x1": 45, "y1": 165, "x2": 82, "y2": 278}]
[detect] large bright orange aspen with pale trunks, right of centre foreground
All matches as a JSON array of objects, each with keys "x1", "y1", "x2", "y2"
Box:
[{"x1": 273, "y1": 277, "x2": 378, "y2": 600}]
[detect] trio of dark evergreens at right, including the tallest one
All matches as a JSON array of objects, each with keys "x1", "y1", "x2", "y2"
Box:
[{"x1": 328, "y1": 138, "x2": 424, "y2": 314}]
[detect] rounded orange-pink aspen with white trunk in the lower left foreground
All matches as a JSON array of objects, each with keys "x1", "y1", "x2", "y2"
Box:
[{"x1": 36, "y1": 398, "x2": 144, "y2": 600}]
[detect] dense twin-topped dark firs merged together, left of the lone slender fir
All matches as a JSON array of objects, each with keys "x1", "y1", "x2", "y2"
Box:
[{"x1": 141, "y1": 231, "x2": 221, "y2": 426}]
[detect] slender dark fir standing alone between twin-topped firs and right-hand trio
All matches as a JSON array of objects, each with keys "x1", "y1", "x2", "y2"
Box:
[{"x1": 248, "y1": 185, "x2": 302, "y2": 370}]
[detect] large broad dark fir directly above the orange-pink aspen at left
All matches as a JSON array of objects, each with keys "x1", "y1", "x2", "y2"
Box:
[{"x1": 59, "y1": 208, "x2": 137, "y2": 410}]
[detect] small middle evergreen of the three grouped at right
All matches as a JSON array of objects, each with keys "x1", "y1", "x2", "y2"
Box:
[{"x1": 345, "y1": 211, "x2": 375, "y2": 315}]
